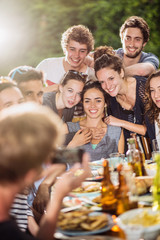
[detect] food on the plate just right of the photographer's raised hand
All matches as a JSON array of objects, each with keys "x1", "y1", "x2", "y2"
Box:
[{"x1": 72, "y1": 182, "x2": 101, "y2": 193}]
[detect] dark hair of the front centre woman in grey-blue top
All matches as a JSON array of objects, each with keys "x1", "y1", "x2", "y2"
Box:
[{"x1": 81, "y1": 80, "x2": 109, "y2": 105}]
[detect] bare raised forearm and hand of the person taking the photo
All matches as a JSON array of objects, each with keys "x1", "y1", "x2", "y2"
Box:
[{"x1": 37, "y1": 154, "x2": 90, "y2": 240}]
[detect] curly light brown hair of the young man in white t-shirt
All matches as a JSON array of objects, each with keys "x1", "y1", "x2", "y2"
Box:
[{"x1": 61, "y1": 25, "x2": 94, "y2": 54}]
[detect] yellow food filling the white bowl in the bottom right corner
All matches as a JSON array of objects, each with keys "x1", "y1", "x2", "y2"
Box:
[{"x1": 123, "y1": 210, "x2": 160, "y2": 227}]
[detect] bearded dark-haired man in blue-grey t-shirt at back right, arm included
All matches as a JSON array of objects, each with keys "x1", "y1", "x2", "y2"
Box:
[{"x1": 116, "y1": 16, "x2": 159, "y2": 77}]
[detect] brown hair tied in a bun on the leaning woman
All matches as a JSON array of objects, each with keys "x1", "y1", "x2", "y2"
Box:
[{"x1": 94, "y1": 46, "x2": 124, "y2": 74}]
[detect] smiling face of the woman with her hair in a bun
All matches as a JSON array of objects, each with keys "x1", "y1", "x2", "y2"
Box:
[{"x1": 96, "y1": 67, "x2": 124, "y2": 97}]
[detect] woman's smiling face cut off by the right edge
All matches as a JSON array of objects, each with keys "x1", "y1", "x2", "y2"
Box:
[{"x1": 150, "y1": 77, "x2": 160, "y2": 108}]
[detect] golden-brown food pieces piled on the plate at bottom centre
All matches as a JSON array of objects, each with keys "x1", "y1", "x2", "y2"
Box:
[{"x1": 58, "y1": 210, "x2": 108, "y2": 231}]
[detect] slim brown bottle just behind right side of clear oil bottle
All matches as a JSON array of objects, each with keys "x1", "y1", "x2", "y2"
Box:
[{"x1": 131, "y1": 133, "x2": 148, "y2": 176}]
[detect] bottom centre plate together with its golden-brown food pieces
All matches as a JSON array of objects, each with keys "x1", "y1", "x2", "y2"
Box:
[{"x1": 57, "y1": 210, "x2": 114, "y2": 236}]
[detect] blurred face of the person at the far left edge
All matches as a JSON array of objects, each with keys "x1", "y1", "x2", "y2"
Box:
[{"x1": 0, "y1": 87, "x2": 24, "y2": 110}]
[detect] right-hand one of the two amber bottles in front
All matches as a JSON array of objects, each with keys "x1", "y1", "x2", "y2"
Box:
[{"x1": 116, "y1": 164, "x2": 130, "y2": 215}]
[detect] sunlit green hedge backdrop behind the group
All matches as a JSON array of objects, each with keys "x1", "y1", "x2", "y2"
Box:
[{"x1": 0, "y1": 0, "x2": 160, "y2": 75}]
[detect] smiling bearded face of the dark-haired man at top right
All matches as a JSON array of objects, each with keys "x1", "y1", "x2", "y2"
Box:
[{"x1": 121, "y1": 28, "x2": 146, "y2": 58}]
